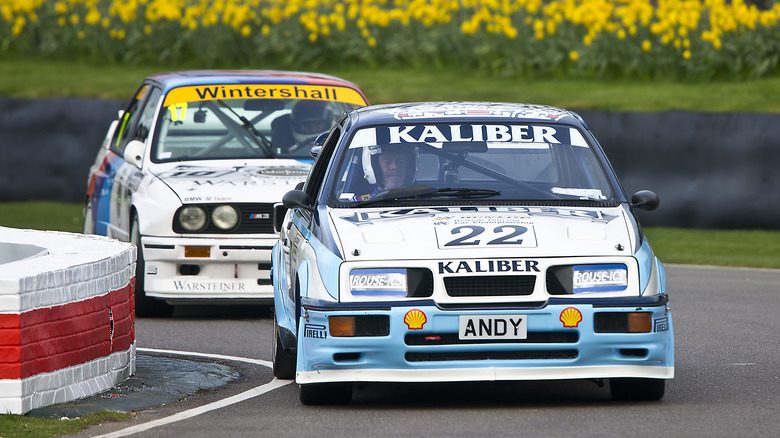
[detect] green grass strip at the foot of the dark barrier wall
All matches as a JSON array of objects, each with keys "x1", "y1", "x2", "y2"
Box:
[{"x1": 0, "y1": 201, "x2": 780, "y2": 269}]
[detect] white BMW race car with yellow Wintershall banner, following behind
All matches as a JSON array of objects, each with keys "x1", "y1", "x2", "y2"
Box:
[{"x1": 84, "y1": 70, "x2": 368, "y2": 316}]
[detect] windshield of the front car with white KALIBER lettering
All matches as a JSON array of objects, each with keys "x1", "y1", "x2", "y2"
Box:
[{"x1": 331, "y1": 123, "x2": 614, "y2": 206}]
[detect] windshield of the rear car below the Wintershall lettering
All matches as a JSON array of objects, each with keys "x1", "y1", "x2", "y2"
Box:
[{"x1": 151, "y1": 87, "x2": 362, "y2": 163}]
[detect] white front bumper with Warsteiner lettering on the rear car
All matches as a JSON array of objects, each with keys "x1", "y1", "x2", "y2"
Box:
[{"x1": 141, "y1": 236, "x2": 277, "y2": 304}]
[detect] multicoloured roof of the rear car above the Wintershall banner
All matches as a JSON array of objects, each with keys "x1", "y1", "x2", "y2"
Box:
[{"x1": 147, "y1": 70, "x2": 363, "y2": 94}]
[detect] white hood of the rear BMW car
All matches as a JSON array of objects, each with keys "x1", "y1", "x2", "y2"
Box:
[{"x1": 156, "y1": 159, "x2": 311, "y2": 203}]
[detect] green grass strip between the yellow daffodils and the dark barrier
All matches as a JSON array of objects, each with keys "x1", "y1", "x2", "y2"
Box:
[{"x1": 0, "y1": 58, "x2": 780, "y2": 113}]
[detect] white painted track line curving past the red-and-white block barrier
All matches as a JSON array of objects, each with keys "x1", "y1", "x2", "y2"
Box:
[{"x1": 93, "y1": 348, "x2": 293, "y2": 438}]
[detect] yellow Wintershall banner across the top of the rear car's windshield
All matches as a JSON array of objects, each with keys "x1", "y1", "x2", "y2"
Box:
[{"x1": 164, "y1": 84, "x2": 366, "y2": 107}]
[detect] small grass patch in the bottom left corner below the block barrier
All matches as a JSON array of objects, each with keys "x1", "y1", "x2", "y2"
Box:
[{"x1": 0, "y1": 411, "x2": 132, "y2": 438}]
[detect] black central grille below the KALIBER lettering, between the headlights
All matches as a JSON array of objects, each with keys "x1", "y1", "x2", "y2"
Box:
[{"x1": 444, "y1": 275, "x2": 536, "y2": 297}]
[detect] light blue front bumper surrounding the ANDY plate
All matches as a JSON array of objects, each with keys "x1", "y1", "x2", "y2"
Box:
[{"x1": 296, "y1": 296, "x2": 674, "y2": 384}]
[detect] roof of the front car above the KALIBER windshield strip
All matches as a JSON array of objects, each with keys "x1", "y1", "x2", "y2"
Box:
[{"x1": 350, "y1": 101, "x2": 587, "y2": 129}]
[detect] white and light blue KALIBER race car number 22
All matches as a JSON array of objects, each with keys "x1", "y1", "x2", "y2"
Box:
[{"x1": 272, "y1": 102, "x2": 674, "y2": 403}]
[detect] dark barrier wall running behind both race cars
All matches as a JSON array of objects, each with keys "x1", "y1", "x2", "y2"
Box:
[{"x1": 0, "y1": 98, "x2": 780, "y2": 229}]
